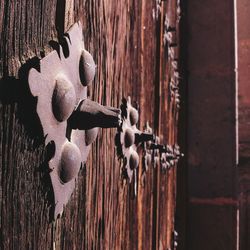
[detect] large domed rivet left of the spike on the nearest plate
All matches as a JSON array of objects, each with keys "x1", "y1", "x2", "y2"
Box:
[{"x1": 52, "y1": 75, "x2": 76, "y2": 122}]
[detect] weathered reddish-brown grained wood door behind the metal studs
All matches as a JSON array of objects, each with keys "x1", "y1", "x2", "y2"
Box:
[{"x1": 0, "y1": 0, "x2": 178, "y2": 249}]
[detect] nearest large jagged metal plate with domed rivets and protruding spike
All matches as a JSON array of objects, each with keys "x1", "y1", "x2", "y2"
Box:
[{"x1": 29, "y1": 22, "x2": 121, "y2": 218}]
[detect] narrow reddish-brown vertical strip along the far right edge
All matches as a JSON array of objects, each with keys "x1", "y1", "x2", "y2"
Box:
[{"x1": 237, "y1": 0, "x2": 250, "y2": 250}]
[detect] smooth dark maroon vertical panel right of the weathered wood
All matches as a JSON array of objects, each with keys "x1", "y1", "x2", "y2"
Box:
[{"x1": 185, "y1": 0, "x2": 238, "y2": 250}]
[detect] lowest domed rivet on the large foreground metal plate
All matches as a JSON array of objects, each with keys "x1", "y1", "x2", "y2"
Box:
[{"x1": 59, "y1": 142, "x2": 81, "y2": 183}]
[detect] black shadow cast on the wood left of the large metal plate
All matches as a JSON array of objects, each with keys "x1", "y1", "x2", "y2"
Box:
[{"x1": 0, "y1": 57, "x2": 55, "y2": 221}]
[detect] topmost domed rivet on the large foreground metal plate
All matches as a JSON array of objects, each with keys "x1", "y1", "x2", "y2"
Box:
[{"x1": 79, "y1": 50, "x2": 96, "y2": 86}]
